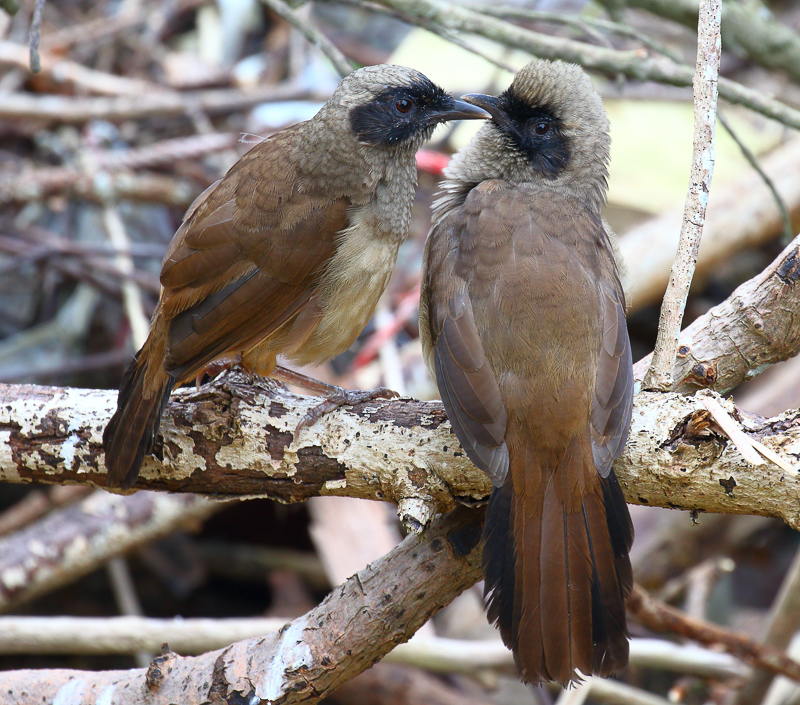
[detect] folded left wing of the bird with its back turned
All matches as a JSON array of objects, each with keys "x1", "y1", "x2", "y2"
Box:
[{"x1": 423, "y1": 187, "x2": 508, "y2": 487}]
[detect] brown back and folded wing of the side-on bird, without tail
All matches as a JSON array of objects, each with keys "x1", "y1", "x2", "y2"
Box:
[{"x1": 155, "y1": 130, "x2": 349, "y2": 380}]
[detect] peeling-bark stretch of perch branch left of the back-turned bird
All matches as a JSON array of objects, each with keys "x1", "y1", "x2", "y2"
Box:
[{"x1": 0, "y1": 373, "x2": 491, "y2": 526}]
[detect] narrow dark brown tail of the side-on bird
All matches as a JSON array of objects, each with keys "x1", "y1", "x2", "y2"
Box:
[{"x1": 103, "y1": 334, "x2": 175, "y2": 490}]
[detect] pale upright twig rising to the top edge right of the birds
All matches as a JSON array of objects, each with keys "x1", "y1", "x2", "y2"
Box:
[{"x1": 642, "y1": 0, "x2": 722, "y2": 391}]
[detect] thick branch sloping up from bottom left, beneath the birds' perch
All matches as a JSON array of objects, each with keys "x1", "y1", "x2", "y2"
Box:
[{"x1": 0, "y1": 510, "x2": 482, "y2": 705}]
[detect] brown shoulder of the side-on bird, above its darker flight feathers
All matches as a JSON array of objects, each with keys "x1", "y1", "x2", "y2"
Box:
[{"x1": 161, "y1": 128, "x2": 350, "y2": 312}]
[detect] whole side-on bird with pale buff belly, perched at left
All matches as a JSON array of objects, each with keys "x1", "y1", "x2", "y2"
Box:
[{"x1": 103, "y1": 65, "x2": 489, "y2": 489}]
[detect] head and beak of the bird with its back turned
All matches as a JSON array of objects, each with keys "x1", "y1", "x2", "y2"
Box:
[{"x1": 447, "y1": 59, "x2": 610, "y2": 201}]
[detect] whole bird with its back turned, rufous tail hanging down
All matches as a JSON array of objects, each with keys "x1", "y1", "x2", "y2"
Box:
[{"x1": 420, "y1": 61, "x2": 633, "y2": 685}]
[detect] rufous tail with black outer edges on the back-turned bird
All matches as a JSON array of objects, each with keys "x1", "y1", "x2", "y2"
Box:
[{"x1": 483, "y1": 438, "x2": 633, "y2": 685}]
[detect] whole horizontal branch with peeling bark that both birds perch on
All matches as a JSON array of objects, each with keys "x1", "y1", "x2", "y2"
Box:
[{"x1": 0, "y1": 374, "x2": 800, "y2": 529}]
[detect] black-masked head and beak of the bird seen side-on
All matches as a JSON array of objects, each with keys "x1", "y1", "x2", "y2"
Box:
[{"x1": 329, "y1": 64, "x2": 489, "y2": 150}]
